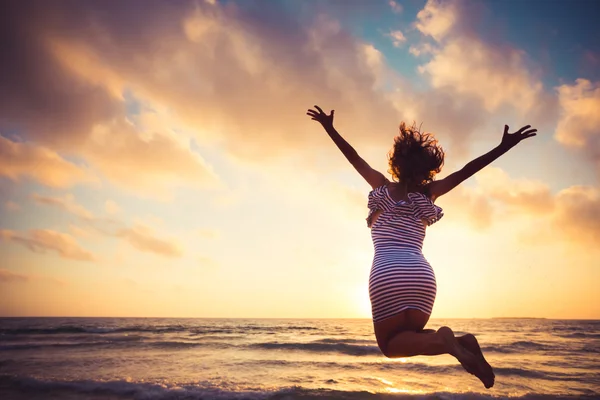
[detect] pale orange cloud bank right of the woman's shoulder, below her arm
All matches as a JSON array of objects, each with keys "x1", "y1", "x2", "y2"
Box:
[{"x1": 437, "y1": 167, "x2": 600, "y2": 247}]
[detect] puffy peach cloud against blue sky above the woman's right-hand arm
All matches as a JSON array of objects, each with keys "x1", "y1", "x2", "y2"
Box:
[{"x1": 415, "y1": 0, "x2": 555, "y2": 114}]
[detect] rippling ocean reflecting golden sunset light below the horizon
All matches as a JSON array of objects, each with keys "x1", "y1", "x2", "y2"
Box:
[{"x1": 0, "y1": 318, "x2": 600, "y2": 400}]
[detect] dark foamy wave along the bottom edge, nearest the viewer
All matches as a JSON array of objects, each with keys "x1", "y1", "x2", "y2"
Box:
[{"x1": 0, "y1": 375, "x2": 597, "y2": 400}]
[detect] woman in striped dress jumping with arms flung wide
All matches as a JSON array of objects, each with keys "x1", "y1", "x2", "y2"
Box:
[{"x1": 307, "y1": 106, "x2": 537, "y2": 388}]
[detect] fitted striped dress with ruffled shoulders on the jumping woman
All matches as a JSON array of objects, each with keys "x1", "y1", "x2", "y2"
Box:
[{"x1": 367, "y1": 184, "x2": 444, "y2": 322}]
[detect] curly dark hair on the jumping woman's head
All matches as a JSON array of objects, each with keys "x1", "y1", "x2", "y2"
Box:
[{"x1": 388, "y1": 122, "x2": 444, "y2": 187}]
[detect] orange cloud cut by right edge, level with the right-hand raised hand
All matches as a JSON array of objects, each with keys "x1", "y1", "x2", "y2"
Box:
[{"x1": 554, "y1": 79, "x2": 600, "y2": 173}]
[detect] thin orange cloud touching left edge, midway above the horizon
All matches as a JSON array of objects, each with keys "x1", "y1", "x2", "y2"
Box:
[{"x1": 0, "y1": 229, "x2": 95, "y2": 261}]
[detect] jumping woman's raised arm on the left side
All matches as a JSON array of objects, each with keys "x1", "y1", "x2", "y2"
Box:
[{"x1": 306, "y1": 106, "x2": 388, "y2": 189}]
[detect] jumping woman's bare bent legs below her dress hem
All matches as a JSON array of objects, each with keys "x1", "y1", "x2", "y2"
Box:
[{"x1": 374, "y1": 309, "x2": 494, "y2": 388}]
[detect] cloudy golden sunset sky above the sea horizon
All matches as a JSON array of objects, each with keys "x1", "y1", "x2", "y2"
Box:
[{"x1": 0, "y1": 0, "x2": 600, "y2": 319}]
